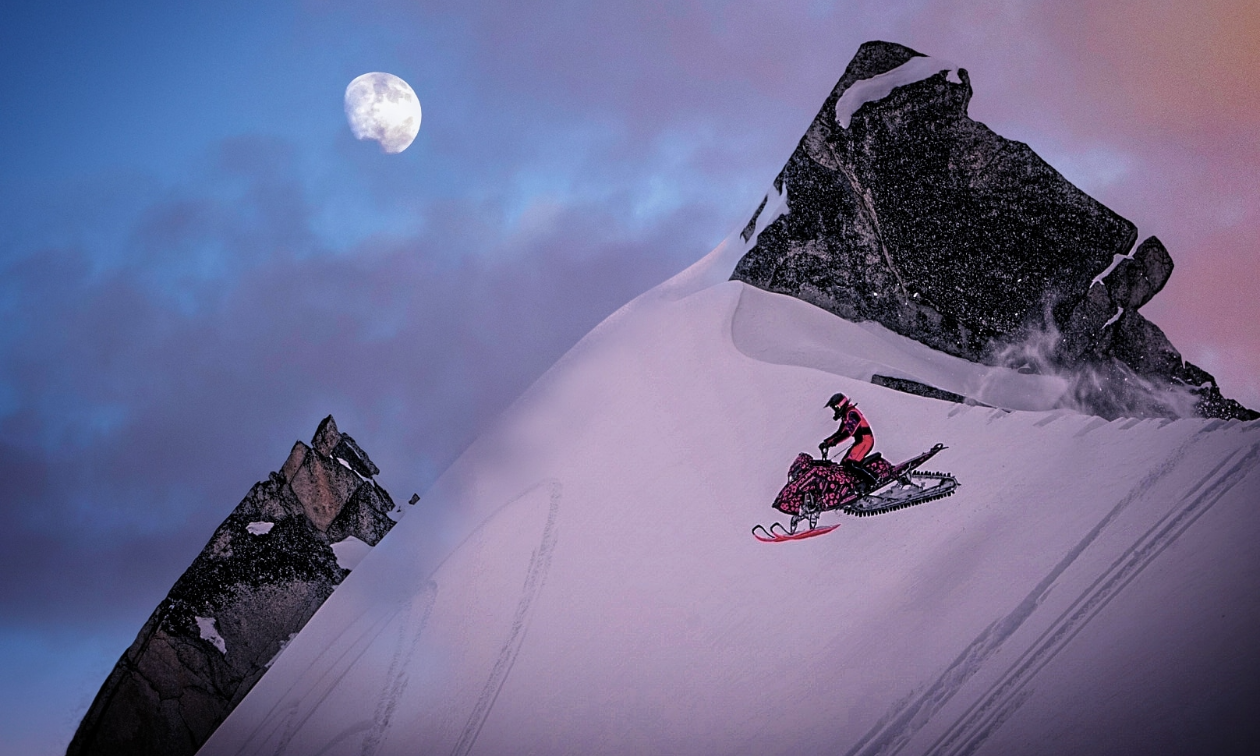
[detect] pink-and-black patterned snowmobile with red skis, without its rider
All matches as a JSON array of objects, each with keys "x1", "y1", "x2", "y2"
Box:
[{"x1": 752, "y1": 444, "x2": 958, "y2": 543}]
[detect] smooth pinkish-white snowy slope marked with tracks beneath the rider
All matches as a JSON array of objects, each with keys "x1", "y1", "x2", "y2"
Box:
[{"x1": 202, "y1": 237, "x2": 1260, "y2": 755}]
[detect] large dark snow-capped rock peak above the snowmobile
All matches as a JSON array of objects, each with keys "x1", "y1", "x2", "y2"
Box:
[{"x1": 732, "y1": 42, "x2": 1254, "y2": 417}]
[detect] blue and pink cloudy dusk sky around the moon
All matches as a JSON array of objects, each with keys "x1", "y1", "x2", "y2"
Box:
[{"x1": 0, "y1": 0, "x2": 1260, "y2": 756}]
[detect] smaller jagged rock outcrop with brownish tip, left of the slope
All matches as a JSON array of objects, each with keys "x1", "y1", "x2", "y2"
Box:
[{"x1": 67, "y1": 416, "x2": 397, "y2": 756}]
